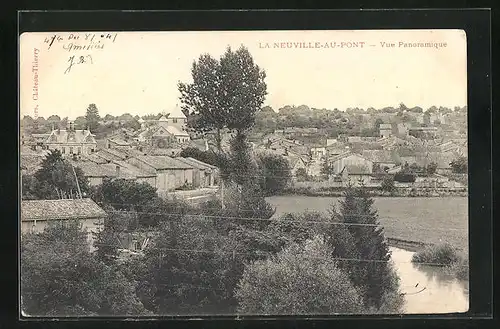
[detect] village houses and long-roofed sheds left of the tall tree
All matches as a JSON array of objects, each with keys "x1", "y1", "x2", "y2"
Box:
[{"x1": 21, "y1": 108, "x2": 218, "y2": 196}]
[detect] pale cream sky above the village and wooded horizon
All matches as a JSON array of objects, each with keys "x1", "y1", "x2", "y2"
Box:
[{"x1": 20, "y1": 30, "x2": 467, "y2": 119}]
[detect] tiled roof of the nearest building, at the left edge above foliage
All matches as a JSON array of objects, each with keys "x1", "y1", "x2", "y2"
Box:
[{"x1": 21, "y1": 199, "x2": 106, "y2": 221}]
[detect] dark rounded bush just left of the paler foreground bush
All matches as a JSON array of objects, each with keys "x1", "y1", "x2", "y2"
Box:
[{"x1": 127, "y1": 218, "x2": 243, "y2": 314}]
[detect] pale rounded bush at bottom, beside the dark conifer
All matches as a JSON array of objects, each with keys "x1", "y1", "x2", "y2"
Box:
[{"x1": 236, "y1": 238, "x2": 363, "y2": 315}]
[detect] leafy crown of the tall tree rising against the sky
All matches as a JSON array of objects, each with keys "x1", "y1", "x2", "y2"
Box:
[{"x1": 178, "y1": 46, "x2": 267, "y2": 150}]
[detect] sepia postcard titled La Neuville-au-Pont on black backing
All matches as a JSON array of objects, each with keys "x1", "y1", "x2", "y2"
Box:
[{"x1": 19, "y1": 30, "x2": 469, "y2": 317}]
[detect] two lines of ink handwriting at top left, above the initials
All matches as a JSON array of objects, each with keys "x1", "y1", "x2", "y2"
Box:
[{"x1": 44, "y1": 32, "x2": 118, "y2": 52}]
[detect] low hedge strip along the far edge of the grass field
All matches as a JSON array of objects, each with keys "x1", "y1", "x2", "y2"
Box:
[{"x1": 280, "y1": 187, "x2": 468, "y2": 198}]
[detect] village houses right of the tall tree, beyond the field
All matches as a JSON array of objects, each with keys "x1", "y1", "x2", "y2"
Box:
[{"x1": 254, "y1": 131, "x2": 467, "y2": 187}]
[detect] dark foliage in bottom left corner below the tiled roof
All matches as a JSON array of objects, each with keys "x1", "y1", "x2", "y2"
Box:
[{"x1": 21, "y1": 222, "x2": 148, "y2": 316}]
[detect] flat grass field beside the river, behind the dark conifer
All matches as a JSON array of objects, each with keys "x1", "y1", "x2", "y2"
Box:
[{"x1": 267, "y1": 196, "x2": 468, "y2": 251}]
